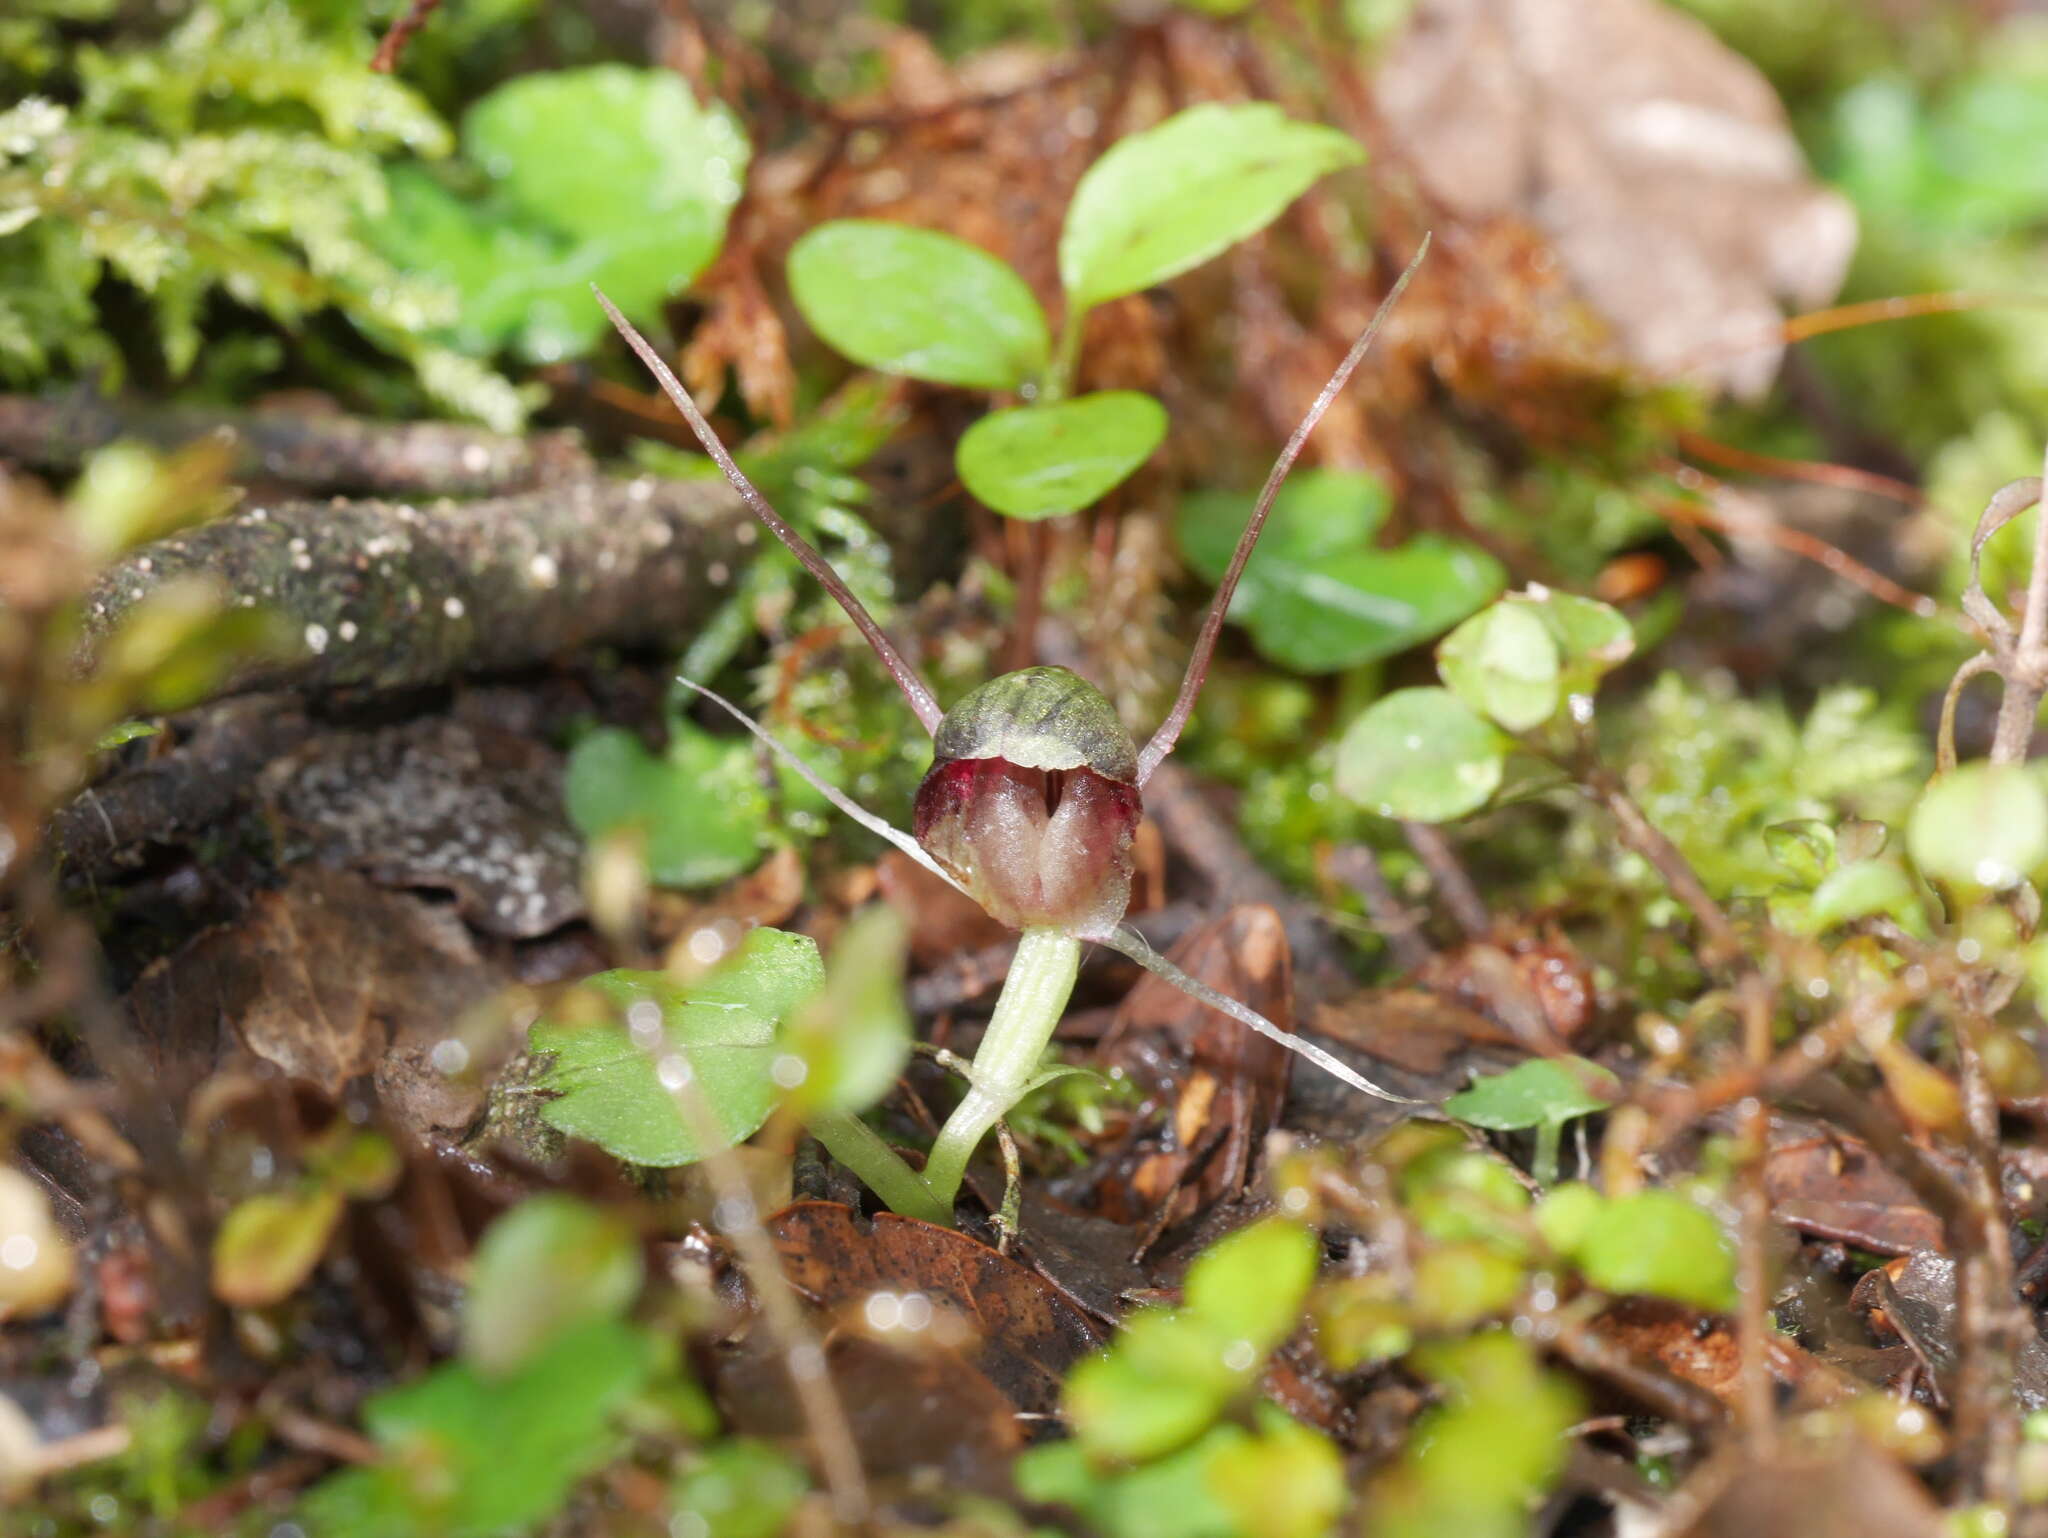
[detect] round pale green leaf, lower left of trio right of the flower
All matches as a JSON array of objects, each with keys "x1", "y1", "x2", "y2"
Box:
[{"x1": 1335, "y1": 688, "x2": 1507, "y2": 823}]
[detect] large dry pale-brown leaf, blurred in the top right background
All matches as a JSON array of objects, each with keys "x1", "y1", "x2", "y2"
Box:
[{"x1": 1374, "y1": 0, "x2": 1855, "y2": 395}]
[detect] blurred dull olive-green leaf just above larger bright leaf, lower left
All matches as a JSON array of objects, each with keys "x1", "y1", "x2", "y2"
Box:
[{"x1": 463, "y1": 1194, "x2": 641, "y2": 1378}]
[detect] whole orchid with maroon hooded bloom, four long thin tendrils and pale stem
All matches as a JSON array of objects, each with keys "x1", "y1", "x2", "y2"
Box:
[{"x1": 585, "y1": 222, "x2": 1423, "y2": 1221}]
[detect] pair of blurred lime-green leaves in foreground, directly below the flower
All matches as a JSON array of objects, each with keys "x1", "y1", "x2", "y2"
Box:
[{"x1": 1063, "y1": 1219, "x2": 1317, "y2": 1460}]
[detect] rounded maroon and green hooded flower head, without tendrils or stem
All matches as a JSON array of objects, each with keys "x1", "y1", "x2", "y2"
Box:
[{"x1": 913, "y1": 668, "x2": 1139, "y2": 938}]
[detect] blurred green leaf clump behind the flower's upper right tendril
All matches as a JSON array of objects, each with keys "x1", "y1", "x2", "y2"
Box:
[{"x1": 1176, "y1": 471, "x2": 1505, "y2": 674}]
